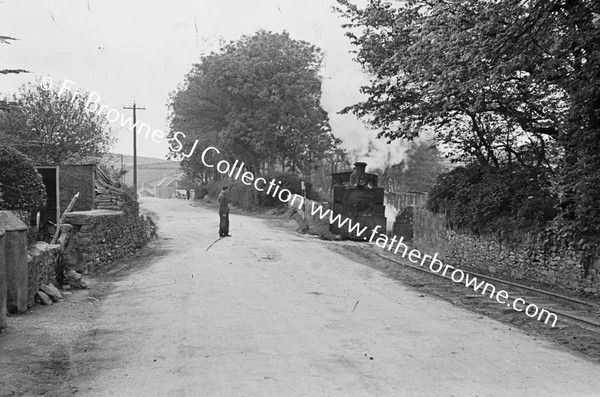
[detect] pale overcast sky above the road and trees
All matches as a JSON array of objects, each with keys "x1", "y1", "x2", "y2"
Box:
[{"x1": 0, "y1": 0, "x2": 408, "y2": 167}]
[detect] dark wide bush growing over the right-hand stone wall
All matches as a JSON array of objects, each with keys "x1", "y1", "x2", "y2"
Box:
[{"x1": 427, "y1": 164, "x2": 557, "y2": 237}]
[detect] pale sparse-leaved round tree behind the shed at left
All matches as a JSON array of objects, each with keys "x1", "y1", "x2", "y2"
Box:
[{"x1": 0, "y1": 82, "x2": 113, "y2": 165}]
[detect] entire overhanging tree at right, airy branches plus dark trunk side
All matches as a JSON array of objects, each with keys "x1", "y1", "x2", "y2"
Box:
[{"x1": 338, "y1": 0, "x2": 600, "y2": 238}]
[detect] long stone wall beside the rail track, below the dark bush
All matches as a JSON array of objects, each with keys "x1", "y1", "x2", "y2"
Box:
[{"x1": 413, "y1": 208, "x2": 600, "y2": 296}]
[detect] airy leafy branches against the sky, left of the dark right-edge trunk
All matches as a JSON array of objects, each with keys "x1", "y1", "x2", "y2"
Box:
[{"x1": 338, "y1": 0, "x2": 564, "y2": 167}]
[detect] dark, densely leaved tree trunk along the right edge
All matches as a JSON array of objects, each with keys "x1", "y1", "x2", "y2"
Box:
[{"x1": 502, "y1": 0, "x2": 600, "y2": 237}]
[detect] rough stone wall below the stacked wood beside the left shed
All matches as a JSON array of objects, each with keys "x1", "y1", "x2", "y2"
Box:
[{"x1": 65, "y1": 210, "x2": 154, "y2": 272}]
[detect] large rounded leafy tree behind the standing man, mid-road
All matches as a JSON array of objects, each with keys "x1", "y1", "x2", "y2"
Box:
[{"x1": 169, "y1": 30, "x2": 334, "y2": 182}]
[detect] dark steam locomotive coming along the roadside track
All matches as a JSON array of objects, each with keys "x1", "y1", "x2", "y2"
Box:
[{"x1": 329, "y1": 162, "x2": 386, "y2": 239}]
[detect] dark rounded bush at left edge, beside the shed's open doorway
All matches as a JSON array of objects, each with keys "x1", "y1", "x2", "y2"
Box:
[{"x1": 0, "y1": 146, "x2": 46, "y2": 212}]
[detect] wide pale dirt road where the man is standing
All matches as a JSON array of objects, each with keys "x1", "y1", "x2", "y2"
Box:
[{"x1": 63, "y1": 199, "x2": 600, "y2": 396}]
